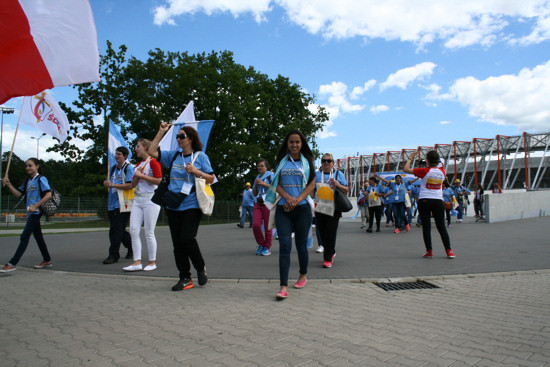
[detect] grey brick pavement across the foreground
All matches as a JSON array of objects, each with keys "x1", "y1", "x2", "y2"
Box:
[{"x1": 0, "y1": 269, "x2": 550, "y2": 367}]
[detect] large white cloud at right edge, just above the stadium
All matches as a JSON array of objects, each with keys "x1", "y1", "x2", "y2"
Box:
[{"x1": 432, "y1": 61, "x2": 550, "y2": 131}]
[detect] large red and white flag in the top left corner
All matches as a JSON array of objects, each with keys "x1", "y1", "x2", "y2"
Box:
[{"x1": 0, "y1": 0, "x2": 99, "y2": 104}]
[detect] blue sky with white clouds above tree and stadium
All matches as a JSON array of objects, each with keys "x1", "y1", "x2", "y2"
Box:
[{"x1": 2, "y1": 0, "x2": 550, "y2": 159}]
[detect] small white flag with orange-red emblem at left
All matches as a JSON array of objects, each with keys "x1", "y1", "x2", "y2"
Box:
[{"x1": 19, "y1": 90, "x2": 69, "y2": 143}]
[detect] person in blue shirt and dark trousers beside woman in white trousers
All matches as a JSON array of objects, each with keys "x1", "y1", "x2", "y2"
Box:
[{"x1": 103, "y1": 147, "x2": 134, "y2": 264}]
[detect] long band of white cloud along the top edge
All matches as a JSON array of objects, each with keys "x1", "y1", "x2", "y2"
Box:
[{"x1": 153, "y1": 0, "x2": 550, "y2": 48}]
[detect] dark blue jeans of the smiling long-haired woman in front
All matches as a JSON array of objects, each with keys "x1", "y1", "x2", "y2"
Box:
[{"x1": 275, "y1": 204, "x2": 312, "y2": 287}]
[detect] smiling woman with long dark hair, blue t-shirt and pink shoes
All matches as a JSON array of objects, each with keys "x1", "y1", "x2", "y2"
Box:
[{"x1": 265, "y1": 130, "x2": 315, "y2": 299}]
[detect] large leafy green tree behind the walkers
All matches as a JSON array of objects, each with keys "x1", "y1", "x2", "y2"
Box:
[{"x1": 55, "y1": 42, "x2": 328, "y2": 198}]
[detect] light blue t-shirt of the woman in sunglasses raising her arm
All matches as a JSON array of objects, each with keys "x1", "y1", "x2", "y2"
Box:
[{"x1": 158, "y1": 150, "x2": 214, "y2": 211}]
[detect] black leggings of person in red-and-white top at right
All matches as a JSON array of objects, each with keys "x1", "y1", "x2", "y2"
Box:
[{"x1": 418, "y1": 199, "x2": 451, "y2": 250}]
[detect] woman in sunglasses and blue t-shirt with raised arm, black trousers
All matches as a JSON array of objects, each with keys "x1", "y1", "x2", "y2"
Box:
[{"x1": 149, "y1": 122, "x2": 214, "y2": 291}]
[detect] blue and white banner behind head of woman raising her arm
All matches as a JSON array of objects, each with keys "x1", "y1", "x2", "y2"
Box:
[{"x1": 159, "y1": 101, "x2": 214, "y2": 152}]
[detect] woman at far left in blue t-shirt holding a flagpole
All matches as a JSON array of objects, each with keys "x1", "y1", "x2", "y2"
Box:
[{"x1": 0, "y1": 158, "x2": 52, "y2": 273}]
